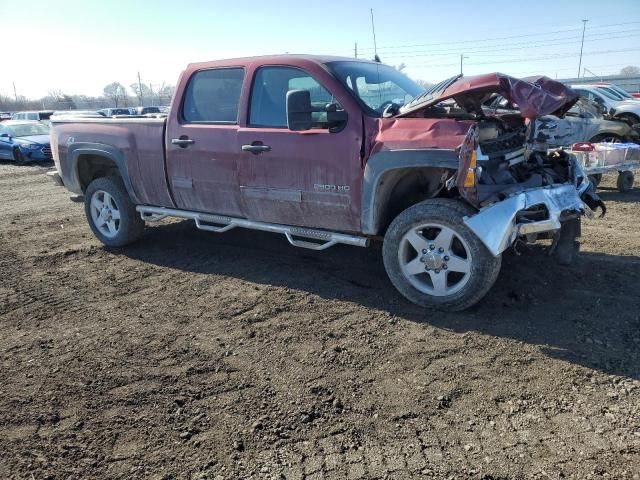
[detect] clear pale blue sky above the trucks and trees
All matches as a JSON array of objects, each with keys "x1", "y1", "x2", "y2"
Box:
[{"x1": 0, "y1": 0, "x2": 640, "y2": 98}]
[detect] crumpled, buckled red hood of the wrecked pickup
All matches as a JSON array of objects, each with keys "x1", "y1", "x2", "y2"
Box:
[{"x1": 397, "y1": 73, "x2": 579, "y2": 118}]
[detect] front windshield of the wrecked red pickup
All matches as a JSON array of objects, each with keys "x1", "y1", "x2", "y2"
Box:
[{"x1": 326, "y1": 62, "x2": 424, "y2": 117}]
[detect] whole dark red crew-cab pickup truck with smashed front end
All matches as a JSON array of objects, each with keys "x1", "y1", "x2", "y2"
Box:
[{"x1": 51, "y1": 55, "x2": 601, "y2": 310}]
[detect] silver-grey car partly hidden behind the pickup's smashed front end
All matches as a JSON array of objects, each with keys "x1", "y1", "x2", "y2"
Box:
[{"x1": 485, "y1": 96, "x2": 640, "y2": 148}]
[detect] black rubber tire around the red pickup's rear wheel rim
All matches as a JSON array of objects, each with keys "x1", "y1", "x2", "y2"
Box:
[{"x1": 84, "y1": 176, "x2": 144, "y2": 247}]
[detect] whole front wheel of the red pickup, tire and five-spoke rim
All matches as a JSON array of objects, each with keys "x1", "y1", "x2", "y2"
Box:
[{"x1": 382, "y1": 199, "x2": 502, "y2": 311}]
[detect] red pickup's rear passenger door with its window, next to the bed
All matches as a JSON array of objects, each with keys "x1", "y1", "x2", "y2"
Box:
[{"x1": 166, "y1": 68, "x2": 244, "y2": 216}]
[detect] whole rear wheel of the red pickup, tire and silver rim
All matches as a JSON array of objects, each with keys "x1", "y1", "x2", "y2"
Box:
[{"x1": 84, "y1": 177, "x2": 144, "y2": 247}]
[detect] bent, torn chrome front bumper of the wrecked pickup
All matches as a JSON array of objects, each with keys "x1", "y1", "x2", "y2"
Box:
[{"x1": 464, "y1": 184, "x2": 588, "y2": 257}]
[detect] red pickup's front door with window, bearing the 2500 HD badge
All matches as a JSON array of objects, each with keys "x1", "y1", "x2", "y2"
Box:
[{"x1": 238, "y1": 65, "x2": 362, "y2": 231}]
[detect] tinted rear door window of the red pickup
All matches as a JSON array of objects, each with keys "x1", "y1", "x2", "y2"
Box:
[{"x1": 182, "y1": 68, "x2": 244, "y2": 123}]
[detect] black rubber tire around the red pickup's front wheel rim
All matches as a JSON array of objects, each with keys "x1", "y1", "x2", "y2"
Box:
[{"x1": 382, "y1": 198, "x2": 502, "y2": 311}]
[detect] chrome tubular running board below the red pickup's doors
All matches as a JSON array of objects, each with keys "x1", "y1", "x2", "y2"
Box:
[{"x1": 136, "y1": 205, "x2": 369, "y2": 250}]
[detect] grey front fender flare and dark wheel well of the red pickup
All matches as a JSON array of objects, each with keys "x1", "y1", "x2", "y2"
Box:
[{"x1": 361, "y1": 149, "x2": 458, "y2": 235}]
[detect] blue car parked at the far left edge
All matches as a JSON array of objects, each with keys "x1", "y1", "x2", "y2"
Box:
[{"x1": 0, "y1": 120, "x2": 52, "y2": 163}]
